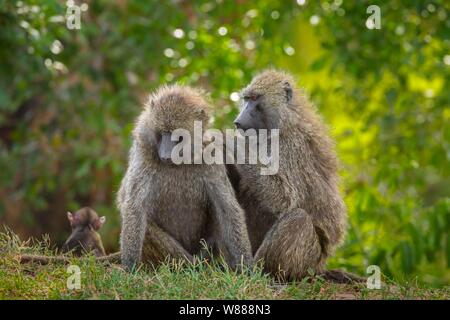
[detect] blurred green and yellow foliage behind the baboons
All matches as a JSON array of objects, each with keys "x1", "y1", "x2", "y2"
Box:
[{"x1": 0, "y1": 0, "x2": 450, "y2": 285}]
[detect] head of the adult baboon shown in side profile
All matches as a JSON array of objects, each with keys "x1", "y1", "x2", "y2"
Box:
[{"x1": 234, "y1": 70, "x2": 295, "y2": 130}]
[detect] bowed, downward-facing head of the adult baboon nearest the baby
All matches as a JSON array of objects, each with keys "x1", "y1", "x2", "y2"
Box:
[{"x1": 139, "y1": 85, "x2": 209, "y2": 162}]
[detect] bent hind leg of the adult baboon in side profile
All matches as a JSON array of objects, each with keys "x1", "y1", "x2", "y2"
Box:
[{"x1": 255, "y1": 210, "x2": 322, "y2": 281}]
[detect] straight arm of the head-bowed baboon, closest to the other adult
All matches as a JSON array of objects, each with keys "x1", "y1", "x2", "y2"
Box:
[{"x1": 205, "y1": 168, "x2": 252, "y2": 267}]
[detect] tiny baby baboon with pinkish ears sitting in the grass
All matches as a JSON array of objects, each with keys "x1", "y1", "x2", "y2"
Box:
[{"x1": 63, "y1": 207, "x2": 106, "y2": 254}]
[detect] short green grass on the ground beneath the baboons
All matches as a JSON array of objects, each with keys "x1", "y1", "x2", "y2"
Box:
[{"x1": 0, "y1": 232, "x2": 450, "y2": 299}]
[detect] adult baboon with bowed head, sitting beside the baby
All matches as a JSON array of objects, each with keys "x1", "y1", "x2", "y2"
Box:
[{"x1": 117, "y1": 86, "x2": 251, "y2": 269}]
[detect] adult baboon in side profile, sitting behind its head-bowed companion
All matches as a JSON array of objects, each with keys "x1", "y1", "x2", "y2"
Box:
[{"x1": 232, "y1": 70, "x2": 356, "y2": 280}]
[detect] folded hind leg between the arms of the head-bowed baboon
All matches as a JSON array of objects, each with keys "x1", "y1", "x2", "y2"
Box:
[{"x1": 142, "y1": 221, "x2": 194, "y2": 265}]
